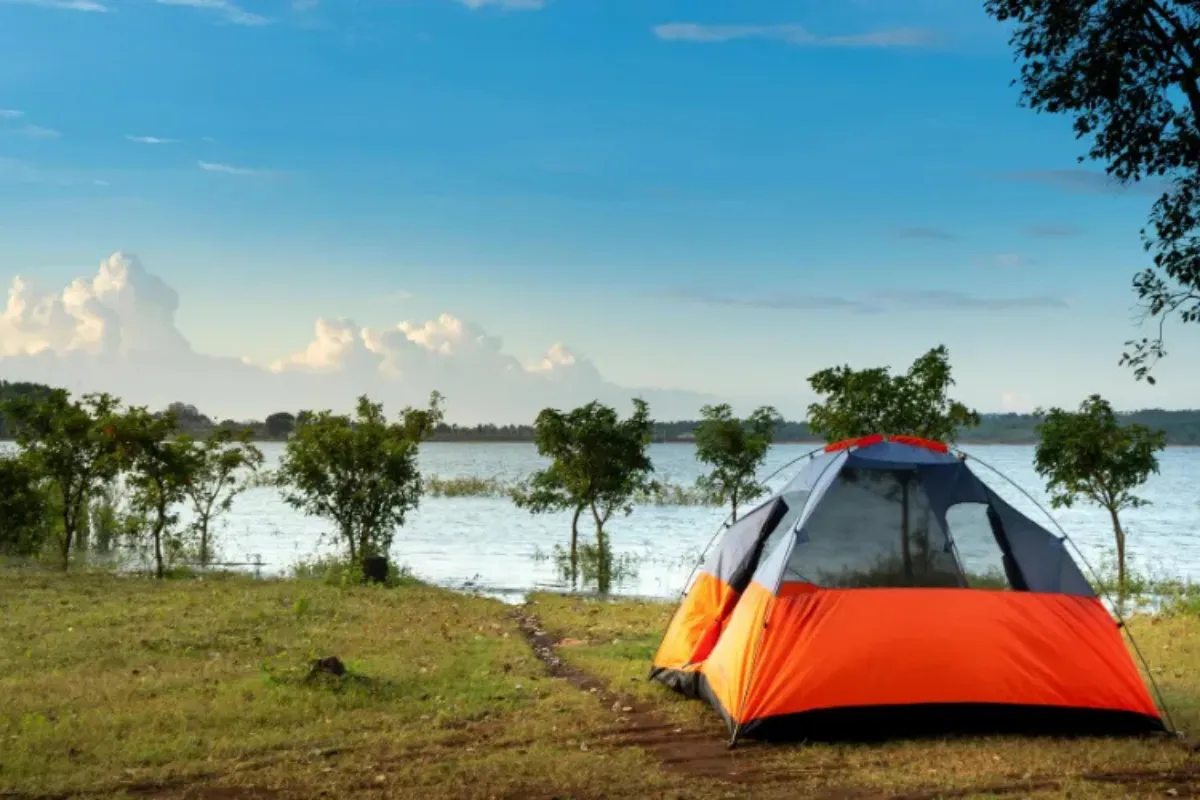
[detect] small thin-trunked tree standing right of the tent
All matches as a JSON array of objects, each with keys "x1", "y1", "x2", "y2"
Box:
[{"x1": 1034, "y1": 395, "x2": 1166, "y2": 600}]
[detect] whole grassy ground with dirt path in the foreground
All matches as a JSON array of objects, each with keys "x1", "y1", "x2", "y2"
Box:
[{"x1": 0, "y1": 572, "x2": 1200, "y2": 800}]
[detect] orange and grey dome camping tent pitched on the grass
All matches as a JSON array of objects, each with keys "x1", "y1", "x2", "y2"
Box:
[{"x1": 650, "y1": 435, "x2": 1165, "y2": 744}]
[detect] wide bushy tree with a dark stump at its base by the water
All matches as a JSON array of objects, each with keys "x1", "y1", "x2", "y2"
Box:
[{"x1": 277, "y1": 392, "x2": 442, "y2": 566}]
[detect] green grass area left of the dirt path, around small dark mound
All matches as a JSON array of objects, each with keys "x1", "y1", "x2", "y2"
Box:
[{"x1": 0, "y1": 572, "x2": 700, "y2": 798}]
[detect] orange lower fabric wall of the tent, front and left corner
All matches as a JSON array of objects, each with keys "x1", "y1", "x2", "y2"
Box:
[{"x1": 701, "y1": 582, "x2": 1159, "y2": 724}]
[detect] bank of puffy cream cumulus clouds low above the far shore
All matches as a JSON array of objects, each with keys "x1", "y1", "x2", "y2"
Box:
[{"x1": 0, "y1": 253, "x2": 714, "y2": 423}]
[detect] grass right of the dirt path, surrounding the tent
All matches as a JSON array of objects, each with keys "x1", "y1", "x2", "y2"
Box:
[{"x1": 529, "y1": 594, "x2": 1200, "y2": 798}]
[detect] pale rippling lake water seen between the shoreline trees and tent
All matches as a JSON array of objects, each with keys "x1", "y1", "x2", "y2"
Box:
[{"x1": 171, "y1": 443, "x2": 1200, "y2": 597}]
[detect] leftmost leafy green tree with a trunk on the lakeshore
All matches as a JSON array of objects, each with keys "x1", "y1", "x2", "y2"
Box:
[{"x1": 6, "y1": 389, "x2": 121, "y2": 570}]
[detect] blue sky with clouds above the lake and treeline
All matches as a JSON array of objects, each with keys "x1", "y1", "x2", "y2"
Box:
[{"x1": 0, "y1": 0, "x2": 1200, "y2": 423}]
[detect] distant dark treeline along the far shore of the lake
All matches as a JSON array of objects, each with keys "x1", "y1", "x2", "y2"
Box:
[{"x1": 7, "y1": 381, "x2": 1200, "y2": 445}]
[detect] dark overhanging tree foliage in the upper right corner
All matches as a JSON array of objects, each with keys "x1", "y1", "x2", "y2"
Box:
[{"x1": 985, "y1": 0, "x2": 1200, "y2": 383}]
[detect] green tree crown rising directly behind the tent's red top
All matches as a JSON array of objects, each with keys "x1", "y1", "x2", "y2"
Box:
[{"x1": 809, "y1": 345, "x2": 980, "y2": 444}]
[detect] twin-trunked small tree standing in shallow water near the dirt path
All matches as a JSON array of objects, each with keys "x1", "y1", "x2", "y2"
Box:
[{"x1": 512, "y1": 399, "x2": 654, "y2": 591}]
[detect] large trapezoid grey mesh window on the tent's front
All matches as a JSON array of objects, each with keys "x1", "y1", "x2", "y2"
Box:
[{"x1": 784, "y1": 468, "x2": 967, "y2": 589}]
